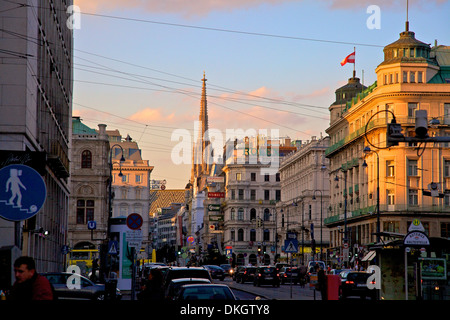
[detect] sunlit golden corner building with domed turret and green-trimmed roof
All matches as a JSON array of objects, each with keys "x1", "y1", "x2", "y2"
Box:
[{"x1": 325, "y1": 23, "x2": 450, "y2": 263}]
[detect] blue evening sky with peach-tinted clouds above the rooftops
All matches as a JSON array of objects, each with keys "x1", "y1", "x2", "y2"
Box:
[{"x1": 73, "y1": 0, "x2": 450, "y2": 189}]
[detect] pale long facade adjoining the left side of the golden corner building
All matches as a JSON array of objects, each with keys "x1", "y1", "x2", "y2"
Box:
[{"x1": 277, "y1": 137, "x2": 330, "y2": 264}]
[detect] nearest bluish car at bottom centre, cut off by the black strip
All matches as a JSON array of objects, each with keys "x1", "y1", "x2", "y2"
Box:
[{"x1": 176, "y1": 284, "x2": 237, "y2": 301}]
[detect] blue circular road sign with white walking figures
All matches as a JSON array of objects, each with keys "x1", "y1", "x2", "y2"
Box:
[{"x1": 0, "y1": 164, "x2": 47, "y2": 221}]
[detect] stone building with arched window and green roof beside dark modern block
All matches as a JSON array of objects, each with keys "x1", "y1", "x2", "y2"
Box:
[{"x1": 68, "y1": 117, "x2": 109, "y2": 258}]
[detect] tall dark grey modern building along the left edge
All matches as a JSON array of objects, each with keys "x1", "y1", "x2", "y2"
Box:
[{"x1": 0, "y1": 0, "x2": 73, "y2": 272}]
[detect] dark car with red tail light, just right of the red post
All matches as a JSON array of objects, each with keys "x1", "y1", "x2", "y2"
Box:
[{"x1": 339, "y1": 271, "x2": 377, "y2": 300}]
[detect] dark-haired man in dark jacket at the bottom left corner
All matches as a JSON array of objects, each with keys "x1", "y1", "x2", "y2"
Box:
[{"x1": 8, "y1": 256, "x2": 56, "y2": 301}]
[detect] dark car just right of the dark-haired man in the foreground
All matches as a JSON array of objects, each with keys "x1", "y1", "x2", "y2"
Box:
[{"x1": 42, "y1": 272, "x2": 122, "y2": 300}]
